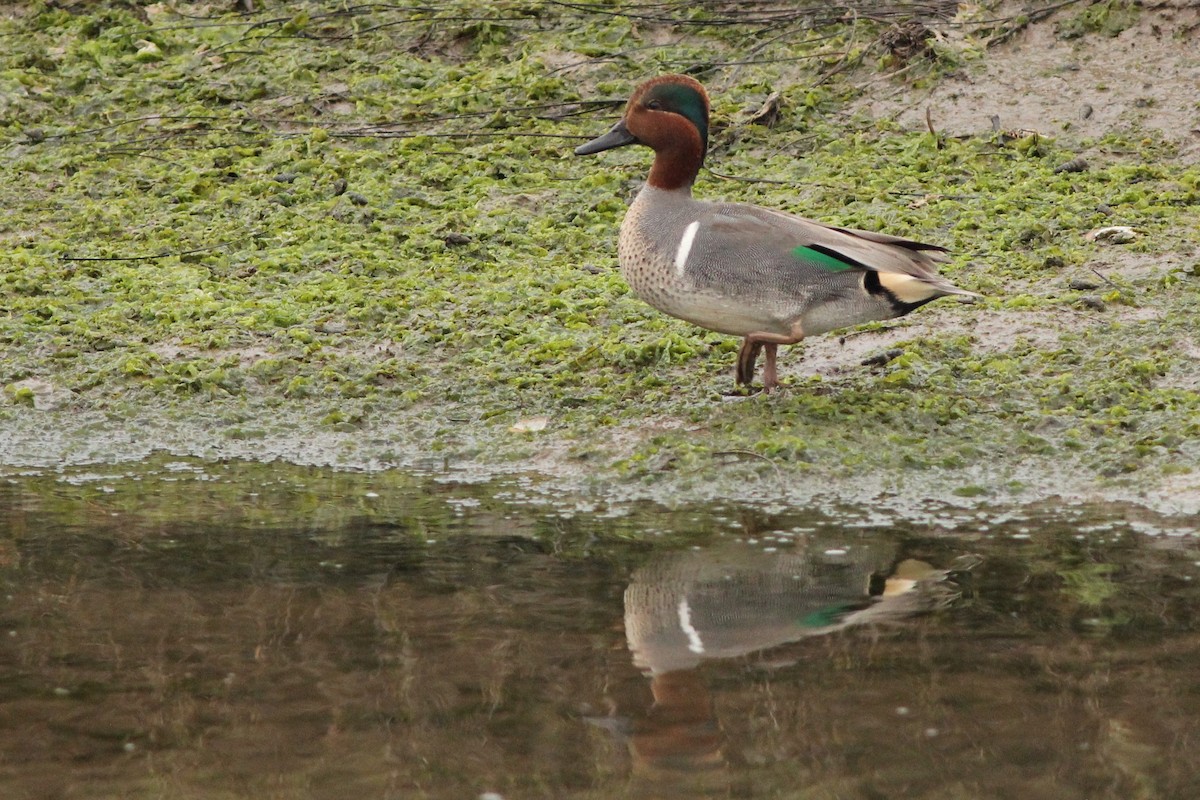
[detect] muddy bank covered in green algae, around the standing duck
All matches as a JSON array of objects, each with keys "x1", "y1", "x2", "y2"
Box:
[{"x1": 0, "y1": 0, "x2": 1200, "y2": 512}]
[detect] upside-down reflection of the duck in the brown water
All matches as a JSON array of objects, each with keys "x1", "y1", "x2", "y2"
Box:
[{"x1": 609, "y1": 541, "x2": 970, "y2": 769}]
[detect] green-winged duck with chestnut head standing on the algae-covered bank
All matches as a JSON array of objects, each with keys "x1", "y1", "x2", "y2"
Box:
[{"x1": 575, "y1": 74, "x2": 978, "y2": 393}]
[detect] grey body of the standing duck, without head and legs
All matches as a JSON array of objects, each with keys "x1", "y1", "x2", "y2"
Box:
[{"x1": 618, "y1": 186, "x2": 953, "y2": 336}]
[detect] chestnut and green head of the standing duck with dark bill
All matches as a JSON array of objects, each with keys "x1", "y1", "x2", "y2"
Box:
[{"x1": 575, "y1": 74, "x2": 709, "y2": 190}]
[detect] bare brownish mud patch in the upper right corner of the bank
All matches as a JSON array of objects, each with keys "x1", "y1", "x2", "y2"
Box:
[{"x1": 856, "y1": 0, "x2": 1200, "y2": 162}]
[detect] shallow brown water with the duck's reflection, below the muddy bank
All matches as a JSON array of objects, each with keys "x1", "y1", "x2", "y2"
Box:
[{"x1": 0, "y1": 459, "x2": 1200, "y2": 800}]
